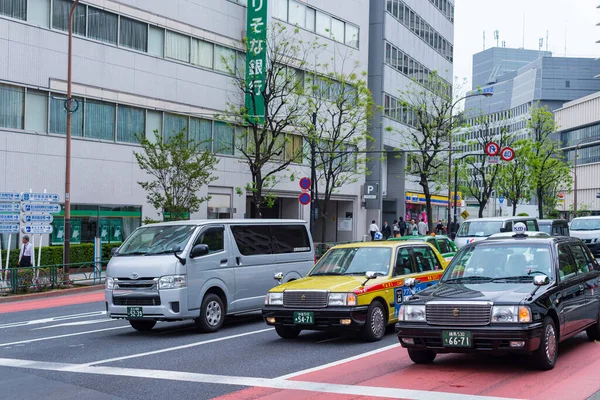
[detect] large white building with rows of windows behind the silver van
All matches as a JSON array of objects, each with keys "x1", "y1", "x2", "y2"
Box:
[{"x1": 0, "y1": 0, "x2": 370, "y2": 248}]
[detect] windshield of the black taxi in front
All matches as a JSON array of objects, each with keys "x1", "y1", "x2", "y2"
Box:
[{"x1": 440, "y1": 243, "x2": 554, "y2": 283}]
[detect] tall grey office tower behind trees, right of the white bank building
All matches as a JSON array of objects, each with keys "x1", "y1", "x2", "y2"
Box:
[{"x1": 365, "y1": 0, "x2": 454, "y2": 224}]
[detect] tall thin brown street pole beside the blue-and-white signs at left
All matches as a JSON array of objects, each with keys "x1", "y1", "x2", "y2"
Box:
[{"x1": 63, "y1": 0, "x2": 79, "y2": 277}]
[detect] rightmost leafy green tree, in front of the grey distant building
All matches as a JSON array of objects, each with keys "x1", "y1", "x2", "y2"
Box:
[{"x1": 526, "y1": 107, "x2": 571, "y2": 218}]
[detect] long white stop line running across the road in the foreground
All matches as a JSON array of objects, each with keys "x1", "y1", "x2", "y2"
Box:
[{"x1": 0, "y1": 358, "x2": 516, "y2": 400}]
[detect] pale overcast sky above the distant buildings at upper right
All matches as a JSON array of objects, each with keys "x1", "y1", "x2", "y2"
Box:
[{"x1": 454, "y1": 0, "x2": 600, "y2": 90}]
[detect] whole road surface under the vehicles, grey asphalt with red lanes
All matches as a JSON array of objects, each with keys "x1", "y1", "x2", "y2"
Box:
[{"x1": 0, "y1": 293, "x2": 600, "y2": 400}]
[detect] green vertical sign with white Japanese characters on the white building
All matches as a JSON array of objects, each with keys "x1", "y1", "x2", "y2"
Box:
[{"x1": 245, "y1": 0, "x2": 269, "y2": 124}]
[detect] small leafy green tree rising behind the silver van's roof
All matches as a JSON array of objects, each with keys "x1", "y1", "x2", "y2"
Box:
[{"x1": 134, "y1": 130, "x2": 218, "y2": 220}]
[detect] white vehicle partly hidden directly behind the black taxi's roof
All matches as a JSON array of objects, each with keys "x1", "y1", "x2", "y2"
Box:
[{"x1": 454, "y1": 217, "x2": 540, "y2": 248}]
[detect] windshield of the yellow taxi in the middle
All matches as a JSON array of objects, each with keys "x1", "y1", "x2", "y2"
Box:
[{"x1": 309, "y1": 247, "x2": 392, "y2": 276}]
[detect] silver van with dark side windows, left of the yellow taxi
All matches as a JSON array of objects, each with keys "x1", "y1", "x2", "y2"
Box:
[{"x1": 105, "y1": 219, "x2": 314, "y2": 332}]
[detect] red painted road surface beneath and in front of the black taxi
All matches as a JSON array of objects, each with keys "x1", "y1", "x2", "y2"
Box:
[{"x1": 219, "y1": 335, "x2": 600, "y2": 400}]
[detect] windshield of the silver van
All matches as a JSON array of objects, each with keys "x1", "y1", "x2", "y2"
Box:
[{"x1": 117, "y1": 225, "x2": 197, "y2": 256}]
